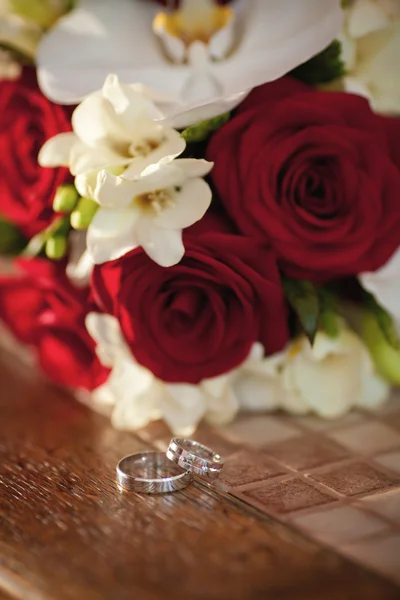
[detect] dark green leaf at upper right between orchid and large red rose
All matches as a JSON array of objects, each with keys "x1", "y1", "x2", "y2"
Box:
[{"x1": 290, "y1": 40, "x2": 346, "y2": 85}]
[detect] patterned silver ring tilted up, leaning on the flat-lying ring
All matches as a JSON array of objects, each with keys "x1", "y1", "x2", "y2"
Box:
[{"x1": 167, "y1": 438, "x2": 224, "y2": 479}]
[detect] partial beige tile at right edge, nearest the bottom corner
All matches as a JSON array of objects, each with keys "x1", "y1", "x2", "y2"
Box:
[{"x1": 342, "y1": 534, "x2": 400, "y2": 582}]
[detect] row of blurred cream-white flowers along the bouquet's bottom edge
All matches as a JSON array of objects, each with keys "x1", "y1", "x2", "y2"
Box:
[{"x1": 86, "y1": 313, "x2": 389, "y2": 435}]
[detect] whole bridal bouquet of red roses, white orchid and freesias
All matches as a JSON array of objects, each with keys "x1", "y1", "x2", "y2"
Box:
[{"x1": 0, "y1": 0, "x2": 400, "y2": 434}]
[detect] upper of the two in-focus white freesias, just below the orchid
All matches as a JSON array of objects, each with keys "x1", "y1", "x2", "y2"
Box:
[{"x1": 39, "y1": 75, "x2": 186, "y2": 180}]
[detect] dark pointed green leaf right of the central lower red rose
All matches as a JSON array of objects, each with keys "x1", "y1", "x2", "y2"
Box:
[{"x1": 283, "y1": 278, "x2": 320, "y2": 344}]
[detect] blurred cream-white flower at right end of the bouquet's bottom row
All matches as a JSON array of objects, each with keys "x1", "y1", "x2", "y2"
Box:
[{"x1": 282, "y1": 326, "x2": 389, "y2": 418}]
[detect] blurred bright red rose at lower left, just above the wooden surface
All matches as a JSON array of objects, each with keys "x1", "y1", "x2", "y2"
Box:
[{"x1": 0, "y1": 259, "x2": 108, "y2": 390}]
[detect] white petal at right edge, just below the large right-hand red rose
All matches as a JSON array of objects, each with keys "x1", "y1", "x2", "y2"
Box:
[{"x1": 359, "y1": 248, "x2": 400, "y2": 335}]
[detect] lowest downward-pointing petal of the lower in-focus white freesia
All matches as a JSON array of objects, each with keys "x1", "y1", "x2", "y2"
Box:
[{"x1": 137, "y1": 219, "x2": 185, "y2": 267}]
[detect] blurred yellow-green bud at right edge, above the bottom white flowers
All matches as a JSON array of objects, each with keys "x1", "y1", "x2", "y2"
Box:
[{"x1": 362, "y1": 312, "x2": 400, "y2": 385}]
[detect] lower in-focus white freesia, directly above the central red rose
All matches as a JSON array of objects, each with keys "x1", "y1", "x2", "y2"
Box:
[{"x1": 87, "y1": 159, "x2": 212, "y2": 267}]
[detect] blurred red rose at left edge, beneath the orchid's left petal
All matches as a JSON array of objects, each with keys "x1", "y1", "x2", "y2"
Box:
[{"x1": 0, "y1": 70, "x2": 71, "y2": 238}]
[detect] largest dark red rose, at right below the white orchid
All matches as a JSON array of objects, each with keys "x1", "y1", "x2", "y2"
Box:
[{"x1": 207, "y1": 78, "x2": 400, "y2": 281}]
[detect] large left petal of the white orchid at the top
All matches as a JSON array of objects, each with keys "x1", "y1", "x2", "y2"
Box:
[{"x1": 38, "y1": 0, "x2": 169, "y2": 104}]
